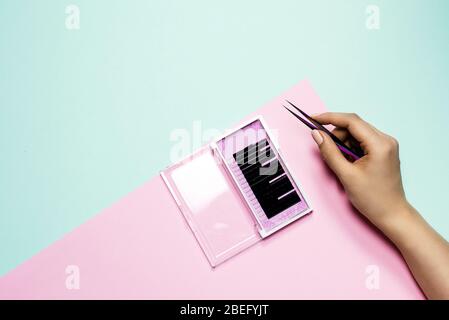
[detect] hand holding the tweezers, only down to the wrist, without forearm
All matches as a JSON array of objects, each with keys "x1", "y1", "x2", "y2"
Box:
[{"x1": 312, "y1": 112, "x2": 407, "y2": 228}]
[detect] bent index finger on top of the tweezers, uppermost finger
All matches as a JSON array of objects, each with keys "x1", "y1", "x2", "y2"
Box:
[{"x1": 313, "y1": 112, "x2": 377, "y2": 143}]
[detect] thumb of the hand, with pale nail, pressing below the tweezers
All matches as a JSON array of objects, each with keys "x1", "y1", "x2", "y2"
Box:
[{"x1": 312, "y1": 130, "x2": 351, "y2": 177}]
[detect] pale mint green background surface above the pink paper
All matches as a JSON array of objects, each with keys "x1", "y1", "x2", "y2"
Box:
[{"x1": 0, "y1": 0, "x2": 449, "y2": 274}]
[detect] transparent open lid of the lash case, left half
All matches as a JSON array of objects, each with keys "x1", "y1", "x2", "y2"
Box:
[{"x1": 161, "y1": 146, "x2": 261, "y2": 267}]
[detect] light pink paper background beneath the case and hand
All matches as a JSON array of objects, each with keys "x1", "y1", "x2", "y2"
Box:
[{"x1": 0, "y1": 82, "x2": 423, "y2": 299}]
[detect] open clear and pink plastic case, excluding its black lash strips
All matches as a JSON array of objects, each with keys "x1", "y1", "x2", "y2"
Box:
[{"x1": 161, "y1": 117, "x2": 311, "y2": 267}]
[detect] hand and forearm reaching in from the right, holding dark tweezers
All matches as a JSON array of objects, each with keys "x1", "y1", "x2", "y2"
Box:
[{"x1": 312, "y1": 113, "x2": 449, "y2": 299}]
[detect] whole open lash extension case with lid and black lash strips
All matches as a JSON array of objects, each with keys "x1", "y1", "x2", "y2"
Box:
[{"x1": 161, "y1": 117, "x2": 312, "y2": 267}]
